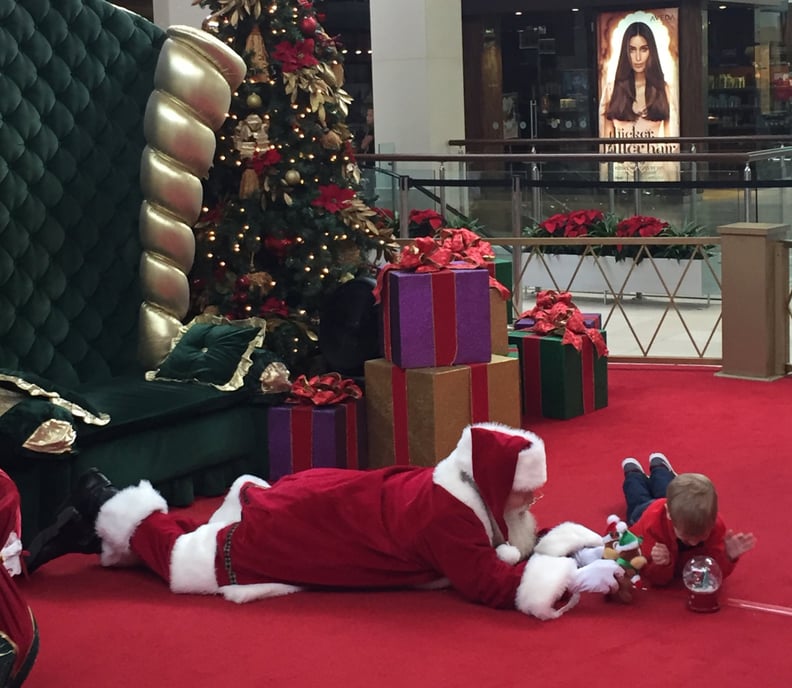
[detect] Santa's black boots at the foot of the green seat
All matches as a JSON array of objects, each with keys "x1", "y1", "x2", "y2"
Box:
[{"x1": 25, "y1": 468, "x2": 118, "y2": 573}]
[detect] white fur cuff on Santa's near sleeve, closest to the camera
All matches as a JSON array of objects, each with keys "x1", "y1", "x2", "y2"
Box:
[{"x1": 515, "y1": 553, "x2": 580, "y2": 620}]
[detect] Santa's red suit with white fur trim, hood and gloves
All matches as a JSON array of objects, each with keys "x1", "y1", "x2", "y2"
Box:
[{"x1": 96, "y1": 423, "x2": 620, "y2": 619}]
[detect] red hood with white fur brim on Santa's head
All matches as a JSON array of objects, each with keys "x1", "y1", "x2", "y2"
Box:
[{"x1": 469, "y1": 423, "x2": 547, "y2": 539}]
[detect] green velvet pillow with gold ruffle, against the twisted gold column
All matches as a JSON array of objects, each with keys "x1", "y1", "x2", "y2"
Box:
[{"x1": 146, "y1": 315, "x2": 266, "y2": 392}]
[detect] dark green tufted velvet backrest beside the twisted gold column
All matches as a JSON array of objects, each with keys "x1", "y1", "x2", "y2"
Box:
[{"x1": 0, "y1": 0, "x2": 165, "y2": 384}]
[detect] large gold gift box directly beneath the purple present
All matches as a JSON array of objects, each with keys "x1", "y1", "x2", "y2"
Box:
[{"x1": 365, "y1": 355, "x2": 521, "y2": 468}]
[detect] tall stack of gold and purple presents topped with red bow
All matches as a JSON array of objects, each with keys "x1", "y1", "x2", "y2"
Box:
[{"x1": 365, "y1": 229, "x2": 520, "y2": 466}]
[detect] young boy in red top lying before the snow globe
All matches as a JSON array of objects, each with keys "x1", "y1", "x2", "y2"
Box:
[{"x1": 622, "y1": 452, "x2": 756, "y2": 585}]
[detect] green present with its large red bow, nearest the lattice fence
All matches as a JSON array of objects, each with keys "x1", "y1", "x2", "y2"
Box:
[{"x1": 509, "y1": 291, "x2": 608, "y2": 419}]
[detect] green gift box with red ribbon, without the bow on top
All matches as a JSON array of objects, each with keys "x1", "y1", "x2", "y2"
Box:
[{"x1": 509, "y1": 330, "x2": 608, "y2": 420}]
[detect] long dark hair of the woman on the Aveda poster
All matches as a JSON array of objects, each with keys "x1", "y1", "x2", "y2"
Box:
[{"x1": 605, "y1": 22, "x2": 670, "y2": 122}]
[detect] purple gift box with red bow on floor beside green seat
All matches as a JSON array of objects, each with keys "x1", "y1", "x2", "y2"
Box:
[{"x1": 267, "y1": 373, "x2": 368, "y2": 481}]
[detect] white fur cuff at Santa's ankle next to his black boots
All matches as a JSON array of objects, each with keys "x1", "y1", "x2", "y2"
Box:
[{"x1": 96, "y1": 480, "x2": 168, "y2": 566}]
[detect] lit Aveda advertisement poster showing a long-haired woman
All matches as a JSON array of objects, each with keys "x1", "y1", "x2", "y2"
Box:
[{"x1": 597, "y1": 8, "x2": 679, "y2": 182}]
